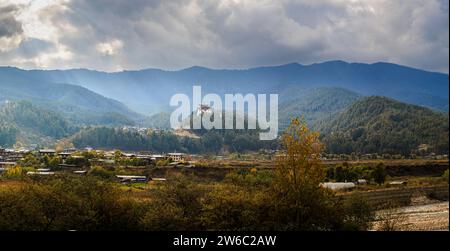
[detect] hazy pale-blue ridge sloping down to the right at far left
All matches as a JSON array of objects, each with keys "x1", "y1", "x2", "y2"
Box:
[{"x1": 0, "y1": 68, "x2": 143, "y2": 124}]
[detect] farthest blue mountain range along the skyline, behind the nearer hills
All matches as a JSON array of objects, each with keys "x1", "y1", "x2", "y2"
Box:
[{"x1": 0, "y1": 61, "x2": 449, "y2": 115}]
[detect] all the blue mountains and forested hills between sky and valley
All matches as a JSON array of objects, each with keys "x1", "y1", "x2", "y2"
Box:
[{"x1": 0, "y1": 61, "x2": 449, "y2": 155}]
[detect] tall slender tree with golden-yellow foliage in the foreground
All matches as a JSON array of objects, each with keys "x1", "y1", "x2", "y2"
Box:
[{"x1": 273, "y1": 118, "x2": 334, "y2": 230}]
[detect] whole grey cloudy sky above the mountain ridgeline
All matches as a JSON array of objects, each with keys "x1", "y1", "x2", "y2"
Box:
[{"x1": 0, "y1": 0, "x2": 449, "y2": 73}]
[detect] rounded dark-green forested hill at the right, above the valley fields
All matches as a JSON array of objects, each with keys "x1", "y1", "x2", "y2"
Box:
[{"x1": 320, "y1": 96, "x2": 449, "y2": 155}]
